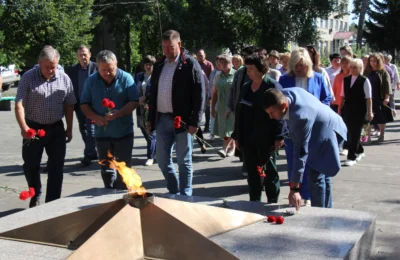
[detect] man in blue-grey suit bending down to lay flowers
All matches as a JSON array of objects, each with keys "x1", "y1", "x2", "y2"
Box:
[{"x1": 263, "y1": 87, "x2": 347, "y2": 210}]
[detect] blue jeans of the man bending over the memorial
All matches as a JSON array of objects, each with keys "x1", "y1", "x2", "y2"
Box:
[{"x1": 308, "y1": 169, "x2": 332, "y2": 208}]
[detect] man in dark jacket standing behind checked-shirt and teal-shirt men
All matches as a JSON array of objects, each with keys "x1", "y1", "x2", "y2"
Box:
[{"x1": 66, "y1": 45, "x2": 97, "y2": 166}]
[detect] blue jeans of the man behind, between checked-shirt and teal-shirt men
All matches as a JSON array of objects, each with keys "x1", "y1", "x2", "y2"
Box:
[{"x1": 75, "y1": 108, "x2": 97, "y2": 159}]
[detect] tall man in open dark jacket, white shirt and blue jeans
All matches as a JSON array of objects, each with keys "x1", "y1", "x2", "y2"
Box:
[{"x1": 147, "y1": 30, "x2": 205, "y2": 196}]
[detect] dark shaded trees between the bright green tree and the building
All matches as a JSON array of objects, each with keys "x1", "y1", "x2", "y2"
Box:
[{"x1": 94, "y1": 0, "x2": 343, "y2": 69}]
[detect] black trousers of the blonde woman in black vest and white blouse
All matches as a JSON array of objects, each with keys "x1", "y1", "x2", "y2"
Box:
[{"x1": 344, "y1": 106, "x2": 366, "y2": 161}]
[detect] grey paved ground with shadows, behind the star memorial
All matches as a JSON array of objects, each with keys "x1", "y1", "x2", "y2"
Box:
[{"x1": 0, "y1": 96, "x2": 400, "y2": 260}]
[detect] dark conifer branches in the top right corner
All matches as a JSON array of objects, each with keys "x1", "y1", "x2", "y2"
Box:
[{"x1": 364, "y1": 0, "x2": 400, "y2": 55}]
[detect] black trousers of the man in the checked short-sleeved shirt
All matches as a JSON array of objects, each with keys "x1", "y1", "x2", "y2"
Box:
[{"x1": 22, "y1": 121, "x2": 66, "y2": 202}]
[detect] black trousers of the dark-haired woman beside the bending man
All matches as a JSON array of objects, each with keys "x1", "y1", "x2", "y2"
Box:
[{"x1": 243, "y1": 145, "x2": 280, "y2": 203}]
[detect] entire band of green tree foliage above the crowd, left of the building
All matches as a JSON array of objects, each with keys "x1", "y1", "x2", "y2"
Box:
[{"x1": 0, "y1": 0, "x2": 343, "y2": 71}]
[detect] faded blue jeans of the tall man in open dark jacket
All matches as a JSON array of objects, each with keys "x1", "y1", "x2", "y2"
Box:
[{"x1": 156, "y1": 114, "x2": 193, "y2": 196}]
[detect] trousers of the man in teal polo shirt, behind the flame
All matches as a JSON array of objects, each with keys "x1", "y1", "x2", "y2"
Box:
[{"x1": 96, "y1": 134, "x2": 133, "y2": 190}]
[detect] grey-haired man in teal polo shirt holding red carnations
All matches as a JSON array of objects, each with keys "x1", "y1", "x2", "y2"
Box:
[{"x1": 80, "y1": 50, "x2": 139, "y2": 189}]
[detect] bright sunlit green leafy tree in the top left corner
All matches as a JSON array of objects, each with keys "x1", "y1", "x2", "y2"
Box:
[{"x1": 0, "y1": 0, "x2": 99, "y2": 67}]
